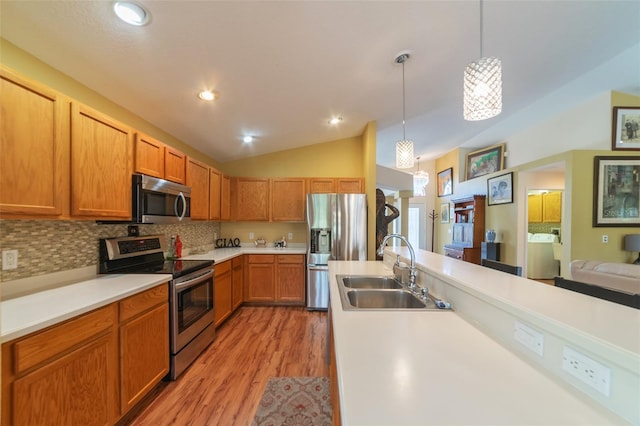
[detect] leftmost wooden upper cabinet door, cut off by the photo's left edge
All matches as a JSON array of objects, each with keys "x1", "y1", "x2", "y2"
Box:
[{"x1": 0, "y1": 68, "x2": 69, "y2": 220}]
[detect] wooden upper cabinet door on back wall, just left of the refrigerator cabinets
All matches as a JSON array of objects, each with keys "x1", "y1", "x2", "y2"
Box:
[{"x1": 271, "y1": 178, "x2": 305, "y2": 222}]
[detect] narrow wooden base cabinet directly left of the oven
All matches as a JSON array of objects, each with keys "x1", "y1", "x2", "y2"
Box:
[{"x1": 119, "y1": 284, "x2": 169, "y2": 415}]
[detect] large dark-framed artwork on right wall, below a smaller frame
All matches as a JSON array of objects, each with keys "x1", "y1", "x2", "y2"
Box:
[{"x1": 593, "y1": 156, "x2": 640, "y2": 227}]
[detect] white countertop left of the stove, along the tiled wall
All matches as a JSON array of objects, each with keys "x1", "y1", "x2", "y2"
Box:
[{"x1": 0, "y1": 274, "x2": 172, "y2": 343}]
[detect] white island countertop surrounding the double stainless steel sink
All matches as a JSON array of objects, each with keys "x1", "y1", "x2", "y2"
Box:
[{"x1": 329, "y1": 256, "x2": 627, "y2": 426}]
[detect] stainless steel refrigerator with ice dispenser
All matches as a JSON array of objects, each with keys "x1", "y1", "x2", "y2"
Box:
[{"x1": 306, "y1": 194, "x2": 367, "y2": 310}]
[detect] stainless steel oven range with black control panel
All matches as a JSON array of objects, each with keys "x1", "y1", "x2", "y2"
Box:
[{"x1": 100, "y1": 235, "x2": 215, "y2": 380}]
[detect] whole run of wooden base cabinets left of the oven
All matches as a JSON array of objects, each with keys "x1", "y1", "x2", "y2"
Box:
[{"x1": 2, "y1": 284, "x2": 169, "y2": 426}]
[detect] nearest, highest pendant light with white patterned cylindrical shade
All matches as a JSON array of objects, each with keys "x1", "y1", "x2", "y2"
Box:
[{"x1": 464, "y1": 0, "x2": 502, "y2": 121}]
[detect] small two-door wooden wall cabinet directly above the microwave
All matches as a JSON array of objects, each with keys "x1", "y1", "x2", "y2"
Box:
[{"x1": 134, "y1": 132, "x2": 186, "y2": 185}]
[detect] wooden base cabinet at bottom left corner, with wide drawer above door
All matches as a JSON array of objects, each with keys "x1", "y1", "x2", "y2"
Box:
[{"x1": 2, "y1": 303, "x2": 120, "y2": 425}]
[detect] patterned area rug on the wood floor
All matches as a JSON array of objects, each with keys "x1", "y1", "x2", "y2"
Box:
[{"x1": 252, "y1": 377, "x2": 331, "y2": 426}]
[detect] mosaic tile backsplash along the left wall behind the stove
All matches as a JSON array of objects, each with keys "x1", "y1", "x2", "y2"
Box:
[{"x1": 0, "y1": 220, "x2": 220, "y2": 282}]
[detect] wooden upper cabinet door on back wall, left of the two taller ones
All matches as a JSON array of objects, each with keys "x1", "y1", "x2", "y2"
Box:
[{"x1": 232, "y1": 177, "x2": 269, "y2": 221}]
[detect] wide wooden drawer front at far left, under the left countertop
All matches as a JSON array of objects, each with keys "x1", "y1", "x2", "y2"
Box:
[{"x1": 14, "y1": 305, "x2": 116, "y2": 374}]
